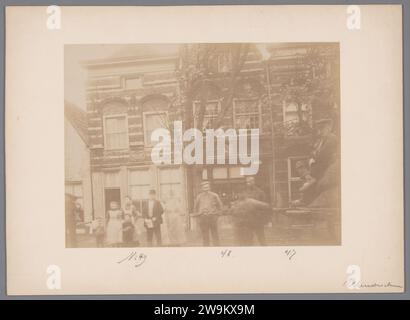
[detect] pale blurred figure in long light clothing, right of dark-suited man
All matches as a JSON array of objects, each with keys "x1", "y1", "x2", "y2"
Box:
[{"x1": 164, "y1": 190, "x2": 186, "y2": 246}]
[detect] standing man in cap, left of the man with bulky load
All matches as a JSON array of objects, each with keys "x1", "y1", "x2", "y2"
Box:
[{"x1": 195, "y1": 181, "x2": 222, "y2": 246}]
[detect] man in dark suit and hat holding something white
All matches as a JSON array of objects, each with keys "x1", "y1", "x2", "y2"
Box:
[{"x1": 142, "y1": 190, "x2": 164, "y2": 246}]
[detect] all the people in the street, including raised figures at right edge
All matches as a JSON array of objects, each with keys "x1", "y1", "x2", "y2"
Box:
[{"x1": 66, "y1": 120, "x2": 340, "y2": 247}]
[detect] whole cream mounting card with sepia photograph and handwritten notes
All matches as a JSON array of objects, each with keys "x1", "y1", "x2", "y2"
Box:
[{"x1": 4, "y1": 0, "x2": 409, "y2": 296}]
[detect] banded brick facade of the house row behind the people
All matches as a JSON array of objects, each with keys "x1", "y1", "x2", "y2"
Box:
[{"x1": 79, "y1": 44, "x2": 340, "y2": 225}]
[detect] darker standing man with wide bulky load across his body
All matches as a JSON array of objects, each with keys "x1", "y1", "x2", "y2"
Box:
[{"x1": 241, "y1": 176, "x2": 269, "y2": 246}]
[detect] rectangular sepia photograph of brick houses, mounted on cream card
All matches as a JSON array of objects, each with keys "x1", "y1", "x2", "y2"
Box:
[{"x1": 64, "y1": 42, "x2": 341, "y2": 248}]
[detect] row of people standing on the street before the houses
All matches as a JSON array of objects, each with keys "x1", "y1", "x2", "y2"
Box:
[{"x1": 92, "y1": 177, "x2": 270, "y2": 247}]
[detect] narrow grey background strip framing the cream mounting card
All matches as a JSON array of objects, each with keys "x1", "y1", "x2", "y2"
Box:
[{"x1": 0, "y1": 0, "x2": 410, "y2": 300}]
